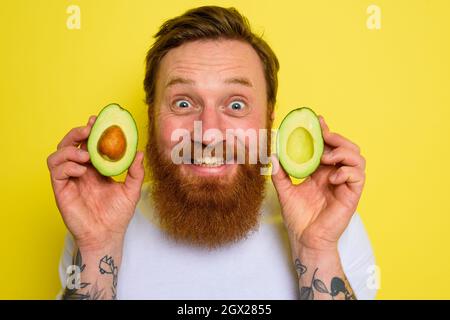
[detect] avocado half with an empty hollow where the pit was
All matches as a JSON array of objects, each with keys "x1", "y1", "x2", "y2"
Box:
[{"x1": 277, "y1": 108, "x2": 324, "y2": 179}]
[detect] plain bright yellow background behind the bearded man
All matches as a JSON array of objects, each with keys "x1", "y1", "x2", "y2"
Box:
[{"x1": 0, "y1": 0, "x2": 450, "y2": 299}]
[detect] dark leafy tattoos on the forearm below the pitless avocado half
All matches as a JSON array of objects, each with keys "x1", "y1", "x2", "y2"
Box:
[{"x1": 295, "y1": 258, "x2": 356, "y2": 300}]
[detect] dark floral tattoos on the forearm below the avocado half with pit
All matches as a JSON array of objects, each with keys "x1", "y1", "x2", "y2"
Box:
[{"x1": 62, "y1": 250, "x2": 118, "y2": 300}]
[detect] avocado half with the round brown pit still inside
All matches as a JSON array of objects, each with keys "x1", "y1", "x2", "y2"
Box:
[{"x1": 87, "y1": 103, "x2": 138, "y2": 176}]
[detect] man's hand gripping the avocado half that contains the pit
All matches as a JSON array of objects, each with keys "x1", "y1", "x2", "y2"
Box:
[{"x1": 47, "y1": 116, "x2": 144, "y2": 251}]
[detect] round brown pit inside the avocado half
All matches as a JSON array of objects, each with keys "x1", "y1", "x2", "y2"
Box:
[{"x1": 97, "y1": 125, "x2": 127, "y2": 161}]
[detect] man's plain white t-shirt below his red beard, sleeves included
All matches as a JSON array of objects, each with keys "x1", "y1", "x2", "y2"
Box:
[{"x1": 59, "y1": 180, "x2": 376, "y2": 300}]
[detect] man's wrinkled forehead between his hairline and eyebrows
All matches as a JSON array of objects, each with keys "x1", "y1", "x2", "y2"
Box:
[{"x1": 156, "y1": 40, "x2": 266, "y2": 94}]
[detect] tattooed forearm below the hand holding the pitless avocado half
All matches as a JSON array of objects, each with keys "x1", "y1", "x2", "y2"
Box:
[{"x1": 294, "y1": 247, "x2": 356, "y2": 300}]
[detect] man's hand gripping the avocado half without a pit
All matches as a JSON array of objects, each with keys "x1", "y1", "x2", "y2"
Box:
[{"x1": 272, "y1": 117, "x2": 365, "y2": 251}]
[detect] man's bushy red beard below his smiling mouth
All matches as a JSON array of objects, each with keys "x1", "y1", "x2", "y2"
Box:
[{"x1": 147, "y1": 138, "x2": 270, "y2": 248}]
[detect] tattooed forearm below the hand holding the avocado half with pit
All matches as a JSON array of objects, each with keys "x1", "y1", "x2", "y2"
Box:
[{"x1": 62, "y1": 245, "x2": 122, "y2": 300}]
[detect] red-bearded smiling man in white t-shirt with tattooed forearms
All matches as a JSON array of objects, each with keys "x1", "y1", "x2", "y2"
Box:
[{"x1": 48, "y1": 6, "x2": 375, "y2": 299}]
